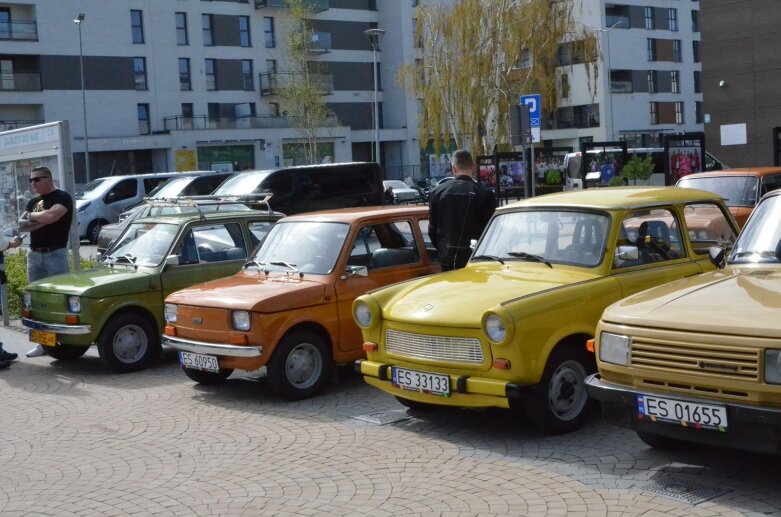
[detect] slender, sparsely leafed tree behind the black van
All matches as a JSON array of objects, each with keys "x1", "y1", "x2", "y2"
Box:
[{"x1": 280, "y1": 0, "x2": 336, "y2": 164}]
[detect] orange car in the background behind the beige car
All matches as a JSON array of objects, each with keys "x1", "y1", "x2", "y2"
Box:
[{"x1": 675, "y1": 167, "x2": 781, "y2": 228}]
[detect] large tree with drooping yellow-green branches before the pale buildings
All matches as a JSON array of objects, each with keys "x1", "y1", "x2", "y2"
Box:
[{"x1": 399, "y1": 0, "x2": 599, "y2": 154}]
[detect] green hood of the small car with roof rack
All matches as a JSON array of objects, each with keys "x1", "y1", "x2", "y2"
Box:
[{"x1": 26, "y1": 265, "x2": 159, "y2": 298}]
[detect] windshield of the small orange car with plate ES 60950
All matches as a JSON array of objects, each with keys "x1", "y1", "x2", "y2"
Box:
[{"x1": 248, "y1": 221, "x2": 350, "y2": 275}]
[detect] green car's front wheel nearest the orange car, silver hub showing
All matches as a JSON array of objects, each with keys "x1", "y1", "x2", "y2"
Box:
[{"x1": 98, "y1": 313, "x2": 161, "y2": 373}]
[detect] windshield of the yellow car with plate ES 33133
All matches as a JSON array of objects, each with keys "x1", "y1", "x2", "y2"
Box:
[{"x1": 472, "y1": 209, "x2": 610, "y2": 267}]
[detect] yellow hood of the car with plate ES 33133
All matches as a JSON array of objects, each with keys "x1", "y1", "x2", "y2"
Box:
[{"x1": 377, "y1": 262, "x2": 600, "y2": 328}]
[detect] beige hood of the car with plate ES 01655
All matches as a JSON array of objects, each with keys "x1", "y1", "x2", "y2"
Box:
[{"x1": 602, "y1": 266, "x2": 781, "y2": 338}]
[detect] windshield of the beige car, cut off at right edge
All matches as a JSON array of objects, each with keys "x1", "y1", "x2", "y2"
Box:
[{"x1": 729, "y1": 196, "x2": 781, "y2": 263}]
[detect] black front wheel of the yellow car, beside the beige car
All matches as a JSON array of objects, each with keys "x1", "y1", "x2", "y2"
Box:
[{"x1": 524, "y1": 346, "x2": 596, "y2": 434}]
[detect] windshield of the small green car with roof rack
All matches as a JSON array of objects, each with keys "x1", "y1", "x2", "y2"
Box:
[{"x1": 104, "y1": 222, "x2": 179, "y2": 266}]
